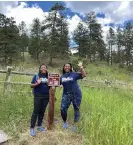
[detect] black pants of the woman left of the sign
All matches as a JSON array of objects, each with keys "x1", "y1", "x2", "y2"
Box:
[{"x1": 30, "y1": 96, "x2": 49, "y2": 128}]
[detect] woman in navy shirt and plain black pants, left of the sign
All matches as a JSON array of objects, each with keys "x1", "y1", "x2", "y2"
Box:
[{"x1": 30, "y1": 64, "x2": 49, "y2": 136}]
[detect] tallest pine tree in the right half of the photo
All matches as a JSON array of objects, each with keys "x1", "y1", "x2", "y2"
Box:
[{"x1": 85, "y1": 12, "x2": 105, "y2": 61}]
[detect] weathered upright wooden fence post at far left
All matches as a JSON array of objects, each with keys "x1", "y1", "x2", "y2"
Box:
[{"x1": 4, "y1": 66, "x2": 12, "y2": 93}]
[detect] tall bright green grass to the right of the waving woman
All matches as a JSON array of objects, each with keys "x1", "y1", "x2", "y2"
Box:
[{"x1": 79, "y1": 89, "x2": 133, "y2": 145}]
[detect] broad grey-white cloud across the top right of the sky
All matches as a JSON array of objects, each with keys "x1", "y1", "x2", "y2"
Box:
[{"x1": 66, "y1": 1, "x2": 133, "y2": 23}]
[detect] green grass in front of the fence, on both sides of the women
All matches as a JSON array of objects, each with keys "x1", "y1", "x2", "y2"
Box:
[{"x1": 0, "y1": 84, "x2": 133, "y2": 145}]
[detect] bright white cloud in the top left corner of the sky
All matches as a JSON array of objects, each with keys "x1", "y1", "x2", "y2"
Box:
[{"x1": 0, "y1": 2, "x2": 48, "y2": 29}]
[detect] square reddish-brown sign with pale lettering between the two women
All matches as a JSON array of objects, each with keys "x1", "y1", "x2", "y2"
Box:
[{"x1": 48, "y1": 73, "x2": 60, "y2": 86}]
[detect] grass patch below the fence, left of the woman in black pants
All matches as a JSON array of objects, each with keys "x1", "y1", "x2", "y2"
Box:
[{"x1": 0, "y1": 94, "x2": 33, "y2": 136}]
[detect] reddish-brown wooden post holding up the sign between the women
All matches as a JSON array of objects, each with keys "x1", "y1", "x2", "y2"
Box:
[{"x1": 47, "y1": 87, "x2": 55, "y2": 130}]
